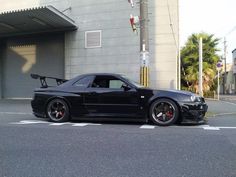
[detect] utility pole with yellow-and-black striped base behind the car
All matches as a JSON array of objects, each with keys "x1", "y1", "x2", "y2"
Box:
[{"x1": 140, "y1": 0, "x2": 149, "y2": 87}]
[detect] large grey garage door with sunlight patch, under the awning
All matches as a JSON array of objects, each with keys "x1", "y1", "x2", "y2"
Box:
[{"x1": 2, "y1": 34, "x2": 64, "y2": 98}]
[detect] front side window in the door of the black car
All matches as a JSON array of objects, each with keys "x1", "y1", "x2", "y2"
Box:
[{"x1": 92, "y1": 76, "x2": 126, "y2": 89}]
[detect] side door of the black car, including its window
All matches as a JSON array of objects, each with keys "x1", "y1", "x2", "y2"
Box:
[{"x1": 87, "y1": 75, "x2": 140, "y2": 117}]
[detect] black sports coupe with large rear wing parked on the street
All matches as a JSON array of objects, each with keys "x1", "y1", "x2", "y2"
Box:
[{"x1": 31, "y1": 73, "x2": 208, "y2": 126}]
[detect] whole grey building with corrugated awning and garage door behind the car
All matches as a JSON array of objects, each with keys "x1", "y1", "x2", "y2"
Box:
[{"x1": 0, "y1": 0, "x2": 179, "y2": 99}]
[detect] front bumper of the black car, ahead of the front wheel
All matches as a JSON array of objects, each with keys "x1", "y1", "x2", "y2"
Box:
[{"x1": 181, "y1": 102, "x2": 208, "y2": 124}]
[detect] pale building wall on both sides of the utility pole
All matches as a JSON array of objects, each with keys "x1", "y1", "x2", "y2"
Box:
[{"x1": 0, "y1": 0, "x2": 179, "y2": 88}]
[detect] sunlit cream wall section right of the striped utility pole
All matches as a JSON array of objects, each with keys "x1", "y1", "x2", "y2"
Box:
[{"x1": 149, "y1": 0, "x2": 179, "y2": 89}]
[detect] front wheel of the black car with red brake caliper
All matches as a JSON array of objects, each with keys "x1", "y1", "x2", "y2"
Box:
[{"x1": 149, "y1": 98, "x2": 179, "y2": 126}]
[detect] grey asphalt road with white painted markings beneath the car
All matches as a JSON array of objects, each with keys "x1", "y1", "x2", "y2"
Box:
[{"x1": 0, "y1": 101, "x2": 236, "y2": 177}]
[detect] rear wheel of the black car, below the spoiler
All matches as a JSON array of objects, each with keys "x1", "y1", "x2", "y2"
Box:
[{"x1": 47, "y1": 99, "x2": 70, "y2": 122}]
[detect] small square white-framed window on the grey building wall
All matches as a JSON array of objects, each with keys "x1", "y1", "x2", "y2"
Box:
[{"x1": 85, "y1": 30, "x2": 102, "y2": 48}]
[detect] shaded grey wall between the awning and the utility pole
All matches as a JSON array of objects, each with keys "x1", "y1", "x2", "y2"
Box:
[{"x1": 62, "y1": 0, "x2": 139, "y2": 80}]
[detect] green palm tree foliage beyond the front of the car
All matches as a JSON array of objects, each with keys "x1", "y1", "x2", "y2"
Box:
[{"x1": 181, "y1": 33, "x2": 220, "y2": 93}]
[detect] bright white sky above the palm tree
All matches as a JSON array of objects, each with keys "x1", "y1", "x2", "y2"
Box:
[{"x1": 179, "y1": 0, "x2": 236, "y2": 63}]
